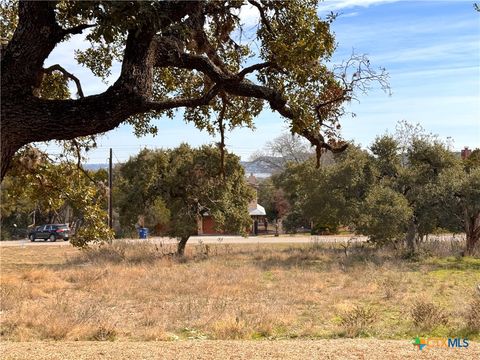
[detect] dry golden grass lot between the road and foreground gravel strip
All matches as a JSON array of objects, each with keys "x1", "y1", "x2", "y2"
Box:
[{"x1": 0, "y1": 242, "x2": 480, "y2": 341}]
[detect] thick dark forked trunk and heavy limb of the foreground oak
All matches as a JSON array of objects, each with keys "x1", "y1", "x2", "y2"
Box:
[{"x1": 0, "y1": 1, "x2": 159, "y2": 180}]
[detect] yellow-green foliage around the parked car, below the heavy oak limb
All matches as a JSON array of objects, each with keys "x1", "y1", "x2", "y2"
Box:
[{"x1": 1, "y1": 147, "x2": 112, "y2": 246}]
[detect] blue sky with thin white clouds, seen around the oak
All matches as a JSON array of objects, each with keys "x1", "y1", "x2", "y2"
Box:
[{"x1": 42, "y1": 0, "x2": 480, "y2": 163}]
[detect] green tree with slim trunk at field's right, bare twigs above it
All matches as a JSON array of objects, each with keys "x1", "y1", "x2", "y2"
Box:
[{"x1": 370, "y1": 128, "x2": 460, "y2": 253}]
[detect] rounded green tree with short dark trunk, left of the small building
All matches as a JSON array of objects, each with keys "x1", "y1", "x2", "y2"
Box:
[{"x1": 117, "y1": 145, "x2": 253, "y2": 255}]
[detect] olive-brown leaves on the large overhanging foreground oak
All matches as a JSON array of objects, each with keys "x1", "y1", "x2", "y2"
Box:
[{"x1": 1, "y1": 0, "x2": 387, "y2": 167}]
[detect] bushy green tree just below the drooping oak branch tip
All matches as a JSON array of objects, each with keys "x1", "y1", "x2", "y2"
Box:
[{"x1": 275, "y1": 146, "x2": 374, "y2": 231}]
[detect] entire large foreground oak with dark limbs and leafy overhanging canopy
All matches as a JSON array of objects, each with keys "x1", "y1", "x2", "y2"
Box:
[{"x1": 0, "y1": 0, "x2": 387, "y2": 179}]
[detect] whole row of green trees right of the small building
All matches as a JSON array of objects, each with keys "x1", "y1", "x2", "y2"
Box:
[{"x1": 274, "y1": 122, "x2": 480, "y2": 251}]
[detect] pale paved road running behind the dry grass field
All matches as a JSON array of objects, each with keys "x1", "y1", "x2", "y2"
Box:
[{"x1": 0, "y1": 235, "x2": 367, "y2": 247}]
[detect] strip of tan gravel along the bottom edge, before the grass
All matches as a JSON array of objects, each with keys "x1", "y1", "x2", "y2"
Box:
[{"x1": 0, "y1": 339, "x2": 480, "y2": 360}]
